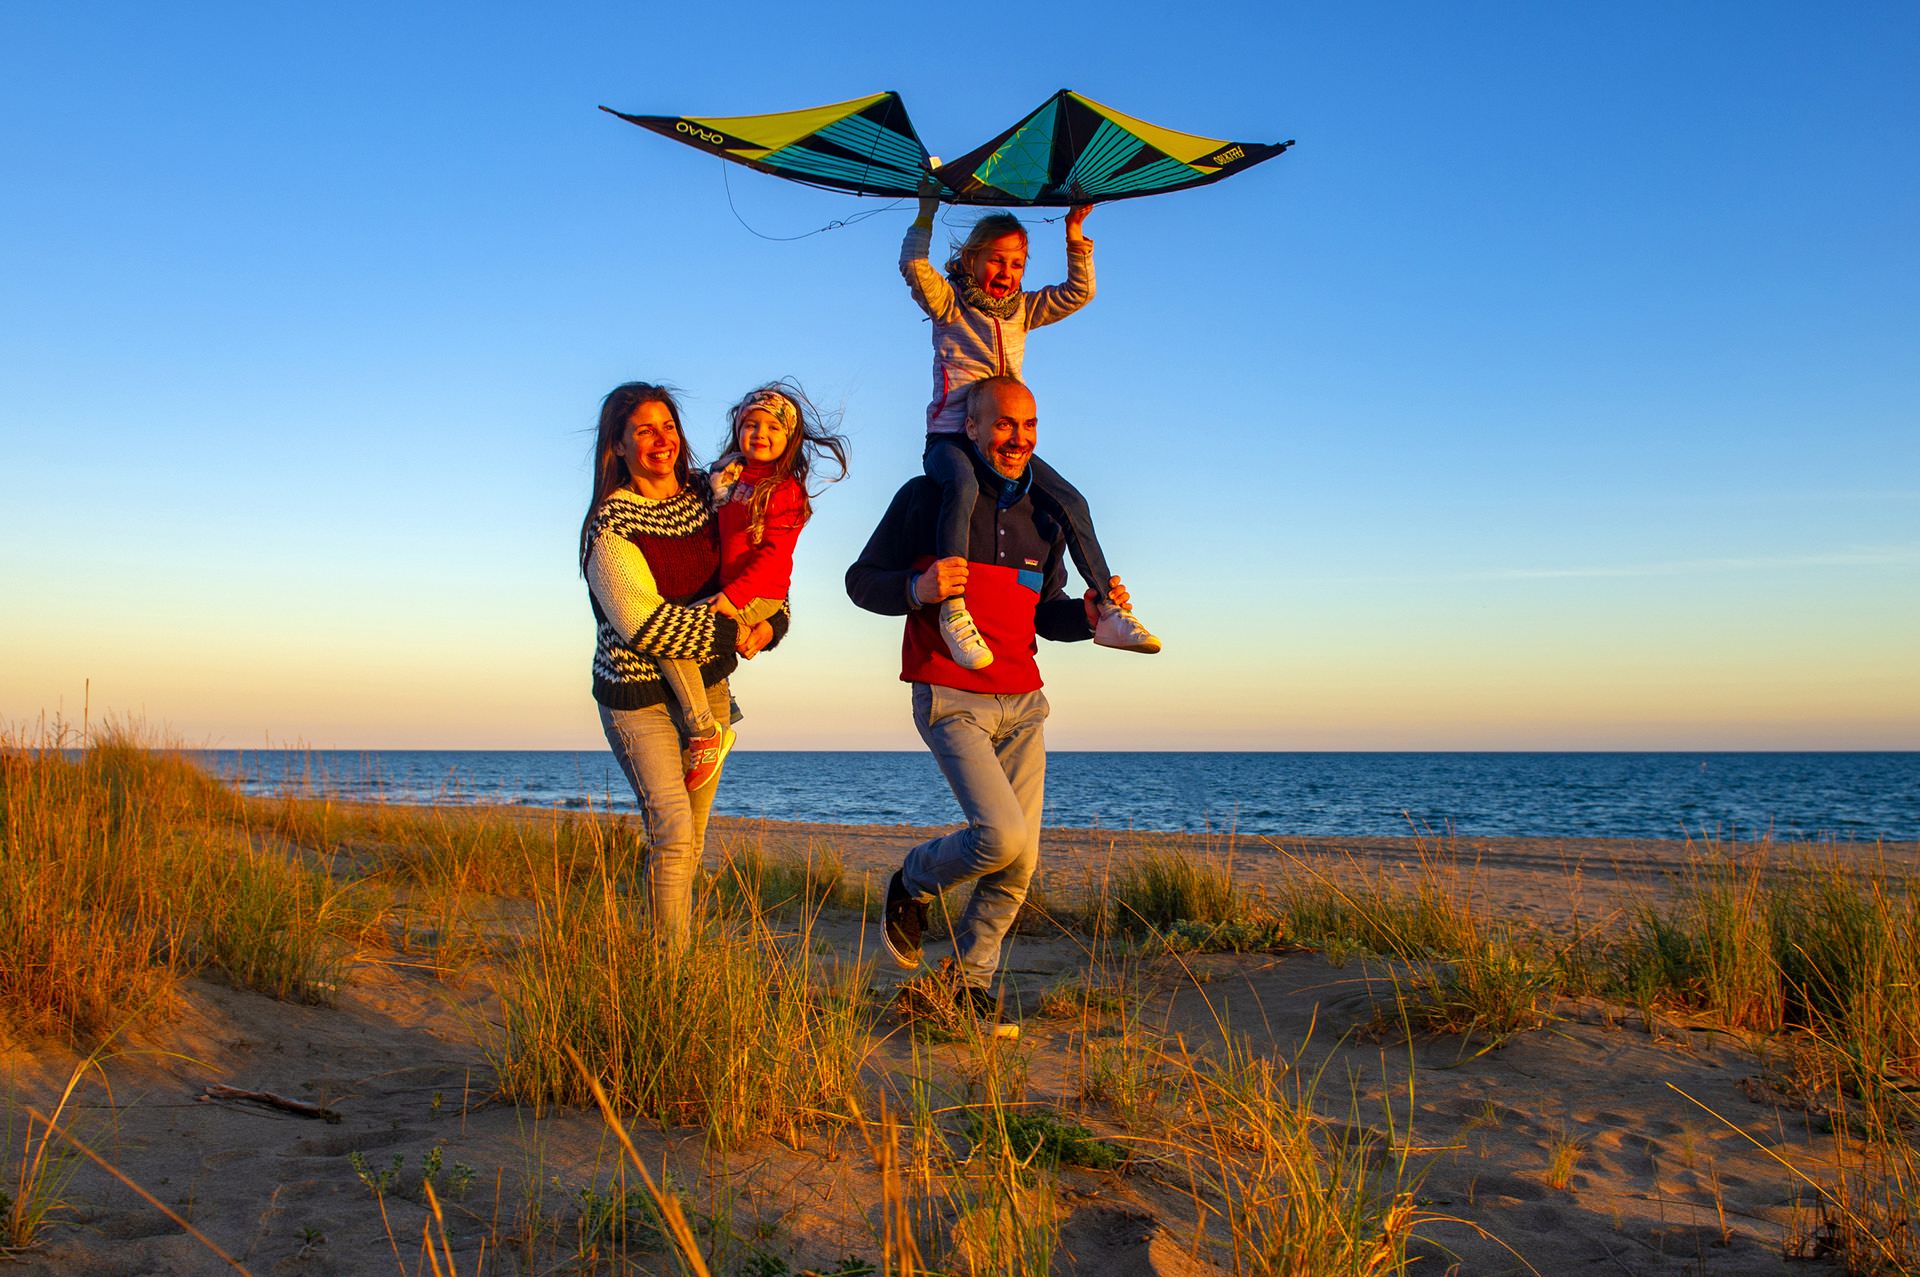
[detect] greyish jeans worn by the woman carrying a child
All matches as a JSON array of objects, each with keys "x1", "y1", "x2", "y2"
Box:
[{"x1": 599, "y1": 678, "x2": 728, "y2": 947}]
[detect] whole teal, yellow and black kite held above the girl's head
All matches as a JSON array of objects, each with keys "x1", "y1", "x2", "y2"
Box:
[{"x1": 601, "y1": 88, "x2": 1292, "y2": 207}]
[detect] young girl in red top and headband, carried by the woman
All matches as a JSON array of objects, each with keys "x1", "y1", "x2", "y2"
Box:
[{"x1": 659, "y1": 382, "x2": 847, "y2": 789}]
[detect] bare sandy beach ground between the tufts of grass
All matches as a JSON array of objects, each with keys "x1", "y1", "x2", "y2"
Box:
[{"x1": 4, "y1": 806, "x2": 1916, "y2": 1275}]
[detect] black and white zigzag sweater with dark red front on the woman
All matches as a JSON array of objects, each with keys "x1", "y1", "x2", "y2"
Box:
[{"x1": 586, "y1": 484, "x2": 787, "y2": 709}]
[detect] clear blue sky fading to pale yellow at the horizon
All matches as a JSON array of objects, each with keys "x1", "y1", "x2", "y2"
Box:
[{"x1": 0, "y1": 2, "x2": 1920, "y2": 749}]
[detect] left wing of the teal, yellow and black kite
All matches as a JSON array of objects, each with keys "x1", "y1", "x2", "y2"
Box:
[{"x1": 601, "y1": 92, "x2": 927, "y2": 196}]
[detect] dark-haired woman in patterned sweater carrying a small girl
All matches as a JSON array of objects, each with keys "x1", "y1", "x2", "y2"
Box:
[{"x1": 580, "y1": 382, "x2": 787, "y2": 947}]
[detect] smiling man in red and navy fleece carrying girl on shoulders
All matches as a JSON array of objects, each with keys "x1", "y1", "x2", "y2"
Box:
[{"x1": 847, "y1": 376, "x2": 1127, "y2": 1033}]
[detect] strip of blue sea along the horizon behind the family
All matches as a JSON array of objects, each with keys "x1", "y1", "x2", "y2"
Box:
[{"x1": 190, "y1": 749, "x2": 1920, "y2": 843}]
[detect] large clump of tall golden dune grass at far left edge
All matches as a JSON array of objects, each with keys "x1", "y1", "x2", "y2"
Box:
[{"x1": 0, "y1": 732, "x2": 361, "y2": 1043}]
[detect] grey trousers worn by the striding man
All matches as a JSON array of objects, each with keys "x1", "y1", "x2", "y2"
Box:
[{"x1": 900, "y1": 684, "x2": 1046, "y2": 989}]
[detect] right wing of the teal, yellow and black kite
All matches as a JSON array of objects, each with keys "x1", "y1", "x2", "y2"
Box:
[{"x1": 935, "y1": 88, "x2": 1292, "y2": 207}]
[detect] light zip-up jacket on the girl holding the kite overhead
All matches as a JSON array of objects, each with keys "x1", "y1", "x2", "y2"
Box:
[{"x1": 900, "y1": 221, "x2": 1092, "y2": 434}]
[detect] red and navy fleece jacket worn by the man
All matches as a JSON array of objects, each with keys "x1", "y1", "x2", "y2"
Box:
[{"x1": 847, "y1": 447, "x2": 1092, "y2": 695}]
